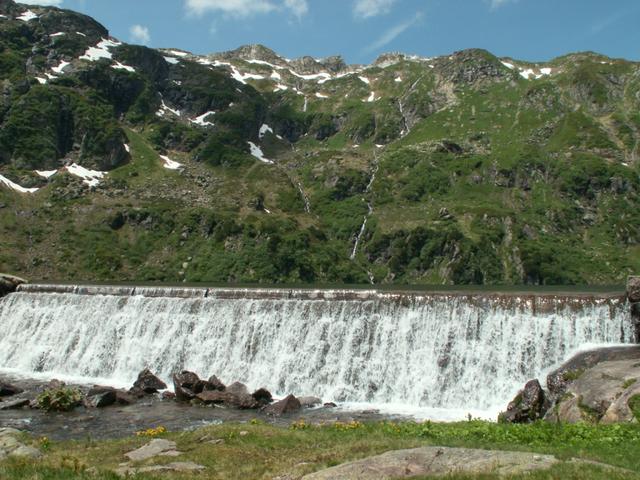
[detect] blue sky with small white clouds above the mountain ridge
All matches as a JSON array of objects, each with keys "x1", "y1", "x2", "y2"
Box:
[{"x1": 17, "y1": 0, "x2": 640, "y2": 63}]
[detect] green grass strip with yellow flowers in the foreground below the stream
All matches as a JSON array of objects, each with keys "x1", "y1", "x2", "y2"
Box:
[{"x1": 0, "y1": 420, "x2": 640, "y2": 480}]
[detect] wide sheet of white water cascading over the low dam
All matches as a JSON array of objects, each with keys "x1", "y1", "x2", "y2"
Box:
[{"x1": 0, "y1": 285, "x2": 634, "y2": 418}]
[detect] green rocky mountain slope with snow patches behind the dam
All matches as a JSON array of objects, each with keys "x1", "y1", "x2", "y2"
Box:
[{"x1": 0, "y1": 0, "x2": 640, "y2": 284}]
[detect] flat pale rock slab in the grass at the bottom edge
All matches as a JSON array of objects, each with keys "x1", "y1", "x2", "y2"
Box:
[{"x1": 302, "y1": 447, "x2": 560, "y2": 480}]
